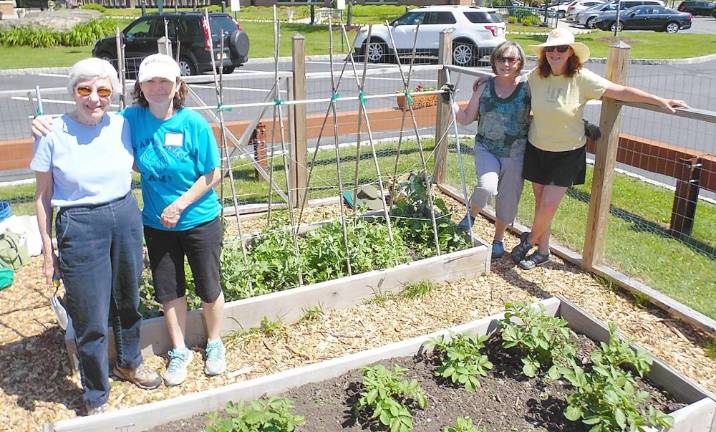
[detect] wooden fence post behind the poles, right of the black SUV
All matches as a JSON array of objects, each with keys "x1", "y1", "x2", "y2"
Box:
[{"x1": 289, "y1": 34, "x2": 308, "y2": 207}]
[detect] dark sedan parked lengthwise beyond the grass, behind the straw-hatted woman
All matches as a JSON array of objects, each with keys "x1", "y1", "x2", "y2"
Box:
[{"x1": 596, "y1": 6, "x2": 691, "y2": 33}]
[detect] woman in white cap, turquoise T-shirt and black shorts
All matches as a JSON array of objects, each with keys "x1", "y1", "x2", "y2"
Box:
[{"x1": 123, "y1": 54, "x2": 226, "y2": 386}]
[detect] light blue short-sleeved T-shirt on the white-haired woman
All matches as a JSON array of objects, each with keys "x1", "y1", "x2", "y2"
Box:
[{"x1": 30, "y1": 113, "x2": 133, "y2": 207}]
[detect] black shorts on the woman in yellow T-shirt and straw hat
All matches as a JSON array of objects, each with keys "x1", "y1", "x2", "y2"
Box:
[{"x1": 522, "y1": 142, "x2": 587, "y2": 187}]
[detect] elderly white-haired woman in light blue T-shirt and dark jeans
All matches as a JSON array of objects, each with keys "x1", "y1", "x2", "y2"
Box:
[{"x1": 30, "y1": 58, "x2": 161, "y2": 414}]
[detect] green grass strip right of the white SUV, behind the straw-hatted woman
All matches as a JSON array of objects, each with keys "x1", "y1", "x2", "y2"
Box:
[{"x1": 507, "y1": 31, "x2": 716, "y2": 59}]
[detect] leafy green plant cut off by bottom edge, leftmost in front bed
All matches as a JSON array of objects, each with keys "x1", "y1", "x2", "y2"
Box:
[{"x1": 206, "y1": 397, "x2": 304, "y2": 432}]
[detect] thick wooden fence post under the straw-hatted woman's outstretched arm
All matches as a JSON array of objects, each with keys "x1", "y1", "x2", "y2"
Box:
[{"x1": 582, "y1": 41, "x2": 631, "y2": 270}]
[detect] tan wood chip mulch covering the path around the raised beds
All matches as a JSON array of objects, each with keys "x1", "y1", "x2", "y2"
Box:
[{"x1": 0, "y1": 200, "x2": 716, "y2": 431}]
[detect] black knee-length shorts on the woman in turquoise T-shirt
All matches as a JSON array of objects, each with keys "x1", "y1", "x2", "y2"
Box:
[{"x1": 144, "y1": 217, "x2": 224, "y2": 303}]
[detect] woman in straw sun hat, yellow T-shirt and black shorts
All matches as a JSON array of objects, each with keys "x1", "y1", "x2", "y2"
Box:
[{"x1": 511, "y1": 29, "x2": 687, "y2": 270}]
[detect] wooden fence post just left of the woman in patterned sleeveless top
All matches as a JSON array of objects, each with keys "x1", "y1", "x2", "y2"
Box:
[{"x1": 433, "y1": 30, "x2": 452, "y2": 184}]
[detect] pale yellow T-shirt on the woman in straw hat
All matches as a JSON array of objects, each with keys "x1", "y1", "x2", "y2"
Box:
[{"x1": 527, "y1": 69, "x2": 611, "y2": 152}]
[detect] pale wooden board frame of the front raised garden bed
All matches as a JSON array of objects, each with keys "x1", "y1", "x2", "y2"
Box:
[{"x1": 45, "y1": 298, "x2": 716, "y2": 432}]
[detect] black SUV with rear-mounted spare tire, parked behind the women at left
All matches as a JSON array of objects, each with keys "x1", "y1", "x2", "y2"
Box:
[{"x1": 92, "y1": 12, "x2": 249, "y2": 75}]
